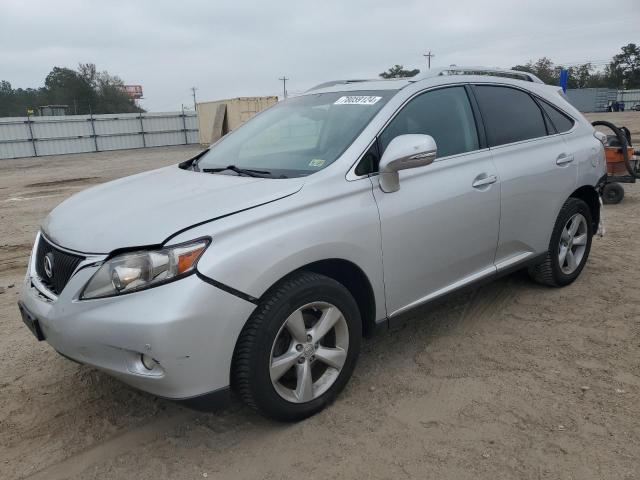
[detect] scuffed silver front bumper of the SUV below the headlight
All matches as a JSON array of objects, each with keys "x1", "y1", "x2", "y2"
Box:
[{"x1": 20, "y1": 240, "x2": 255, "y2": 400}]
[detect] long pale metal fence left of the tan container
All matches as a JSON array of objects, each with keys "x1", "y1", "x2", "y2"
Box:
[{"x1": 0, "y1": 112, "x2": 198, "y2": 159}]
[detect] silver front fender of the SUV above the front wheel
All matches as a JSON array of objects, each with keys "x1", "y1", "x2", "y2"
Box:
[{"x1": 168, "y1": 178, "x2": 386, "y2": 320}]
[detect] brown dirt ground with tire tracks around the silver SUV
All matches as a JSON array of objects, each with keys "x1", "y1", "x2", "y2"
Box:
[{"x1": 0, "y1": 114, "x2": 640, "y2": 480}]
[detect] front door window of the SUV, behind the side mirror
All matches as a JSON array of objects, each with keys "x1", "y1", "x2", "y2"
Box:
[{"x1": 378, "y1": 87, "x2": 478, "y2": 157}]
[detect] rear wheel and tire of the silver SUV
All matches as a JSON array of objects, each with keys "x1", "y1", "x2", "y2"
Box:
[{"x1": 529, "y1": 197, "x2": 594, "y2": 287}]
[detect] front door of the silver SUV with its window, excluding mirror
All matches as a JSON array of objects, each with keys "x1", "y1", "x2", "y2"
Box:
[{"x1": 374, "y1": 86, "x2": 500, "y2": 316}]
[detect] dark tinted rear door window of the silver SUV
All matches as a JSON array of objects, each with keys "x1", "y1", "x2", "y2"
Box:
[{"x1": 474, "y1": 85, "x2": 547, "y2": 147}]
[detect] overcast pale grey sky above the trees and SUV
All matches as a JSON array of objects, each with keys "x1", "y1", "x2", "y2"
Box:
[{"x1": 0, "y1": 0, "x2": 640, "y2": 111}]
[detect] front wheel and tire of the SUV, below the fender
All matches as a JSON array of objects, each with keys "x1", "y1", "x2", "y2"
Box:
[{"x1": 231, "y1": 271, "x2": 362, "y2": 421}]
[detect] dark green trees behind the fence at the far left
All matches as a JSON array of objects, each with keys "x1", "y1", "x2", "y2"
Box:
[{"x1": 0, "y1": 63, "x2": 144, "y2": 117}]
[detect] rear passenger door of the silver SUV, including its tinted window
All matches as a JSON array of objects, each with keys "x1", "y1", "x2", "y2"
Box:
[{"x1": 473, "y1": 84, "x2": 578, "y2": 269}]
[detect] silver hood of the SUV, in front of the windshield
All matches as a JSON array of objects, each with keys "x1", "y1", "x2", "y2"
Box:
[{"x1": 42, "y1": 165, "x2": 304, "y2": 253}]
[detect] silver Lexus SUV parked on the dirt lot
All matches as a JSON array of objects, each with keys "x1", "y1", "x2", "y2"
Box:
[{"x1": 20, "y1": 67, "x2": 605, "y2": 420}]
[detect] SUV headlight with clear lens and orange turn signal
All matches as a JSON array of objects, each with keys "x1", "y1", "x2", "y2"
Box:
[{"x1": 80, "y1": 239, "x2": 210, "y2": 299}]
